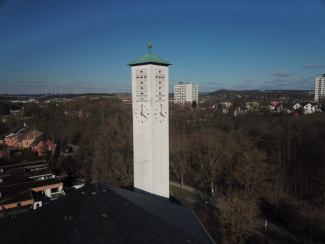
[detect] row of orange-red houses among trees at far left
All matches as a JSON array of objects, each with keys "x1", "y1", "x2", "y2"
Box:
[{"x1": 4, "y1": 123, "x2": 56, "y2": 156}]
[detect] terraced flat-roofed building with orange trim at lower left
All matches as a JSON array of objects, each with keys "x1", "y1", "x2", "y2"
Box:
[{"x1": 0, "y1": 161, "x2": 64, "y2": 216}]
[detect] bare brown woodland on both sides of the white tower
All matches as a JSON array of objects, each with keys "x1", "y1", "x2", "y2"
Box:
[{"x1": 0, "y1": 99, "x2": 325, "y2": 242}]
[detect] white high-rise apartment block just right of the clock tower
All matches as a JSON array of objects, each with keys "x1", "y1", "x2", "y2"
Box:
[{"x1": 174, "y1": 82, "x2": 199, "y2": 104}]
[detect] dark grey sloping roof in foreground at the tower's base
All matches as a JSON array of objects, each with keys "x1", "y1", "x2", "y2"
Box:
[{"x1": 0, "y1": 183, "x2": 213, "y2": 243}]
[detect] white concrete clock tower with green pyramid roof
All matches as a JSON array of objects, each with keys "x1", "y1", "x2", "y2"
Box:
[{"x1": 129, "y1": 42, "x2": 170, "y2": 198}]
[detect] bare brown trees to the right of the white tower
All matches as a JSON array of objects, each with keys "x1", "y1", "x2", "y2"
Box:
[{"x1": 170, "y1": 104, "x2": 325, "y2": 242}]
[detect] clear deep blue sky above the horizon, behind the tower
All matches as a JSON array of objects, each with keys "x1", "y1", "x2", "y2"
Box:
[{"x1": 0, "y1": 0, "x2": 325, "y2": 94}]
